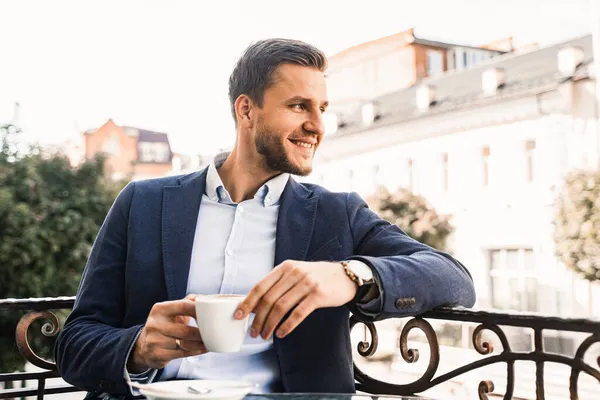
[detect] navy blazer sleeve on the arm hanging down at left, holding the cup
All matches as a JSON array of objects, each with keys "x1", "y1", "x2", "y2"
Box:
[{"x1": 54, "y1": 183, "x2": 142, "y2": 394}]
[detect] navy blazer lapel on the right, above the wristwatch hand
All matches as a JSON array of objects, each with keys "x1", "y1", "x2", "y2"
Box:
[{"x1": 275, "y1": 177, "x2": 319, "y2": 266}]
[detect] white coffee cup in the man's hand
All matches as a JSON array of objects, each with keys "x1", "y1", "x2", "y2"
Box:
[{"x1": 196, "y1": 294, "x2": 248, "y2": 353}]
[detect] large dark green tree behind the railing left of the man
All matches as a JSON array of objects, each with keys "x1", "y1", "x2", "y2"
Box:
[{"x1": 0, "y1": 125, "x2": 123, "y2": 372}]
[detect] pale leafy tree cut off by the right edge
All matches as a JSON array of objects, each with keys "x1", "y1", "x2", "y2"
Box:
[{"x1": 554, "y1": 171, "x2": 600, "y2": 282}]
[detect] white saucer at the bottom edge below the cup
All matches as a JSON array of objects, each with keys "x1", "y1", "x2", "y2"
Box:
[{"x1": 139, "y1": 379, "x2": 255, "y2": 400}]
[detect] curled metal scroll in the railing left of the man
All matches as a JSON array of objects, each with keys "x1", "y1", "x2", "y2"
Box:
[{"x1": 15, "y1": 311, "x2": 60, "y2": 371}]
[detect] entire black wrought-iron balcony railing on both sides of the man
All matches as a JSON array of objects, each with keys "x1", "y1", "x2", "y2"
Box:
[{"x1": 0, "y1": 297, "x2": 600, "y2": 400}]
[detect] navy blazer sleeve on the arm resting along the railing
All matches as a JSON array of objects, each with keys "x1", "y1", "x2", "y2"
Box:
[{"x1": 346, "y1": 193, "x2": 475, "y2": 321}]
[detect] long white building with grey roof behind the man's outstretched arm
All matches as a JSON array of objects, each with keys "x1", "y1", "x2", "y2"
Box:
[{"x1": 310, "y1": 37, "x2": 600, "y2": 317}]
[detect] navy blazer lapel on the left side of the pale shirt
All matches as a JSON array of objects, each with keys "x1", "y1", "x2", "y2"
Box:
[{"x1": 162, "y1": 168, "x2": 207, "y2": 300}]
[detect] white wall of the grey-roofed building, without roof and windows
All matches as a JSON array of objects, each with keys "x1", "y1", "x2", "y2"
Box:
[{"x1": 309, "y1": 82, "x2": 600, "y2": 316}]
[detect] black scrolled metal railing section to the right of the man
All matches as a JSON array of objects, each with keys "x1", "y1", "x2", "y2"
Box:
[{"x1": 350, "y1": 309, "x2": 600, "y2": 400}]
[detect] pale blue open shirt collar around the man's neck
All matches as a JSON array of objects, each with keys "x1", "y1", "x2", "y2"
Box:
[{"x1": 205, "y1": 153, "x2": 290, "y2": 207}]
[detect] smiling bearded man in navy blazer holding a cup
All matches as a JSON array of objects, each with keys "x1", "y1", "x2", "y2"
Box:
[{"x1": 55, "y1": 39, "x2": 475, "y2": 395}]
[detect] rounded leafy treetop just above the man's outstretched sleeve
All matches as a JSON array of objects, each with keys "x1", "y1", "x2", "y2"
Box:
[{"x1": 368, "y1": 187, "x2": 453, "y2": 251}]
